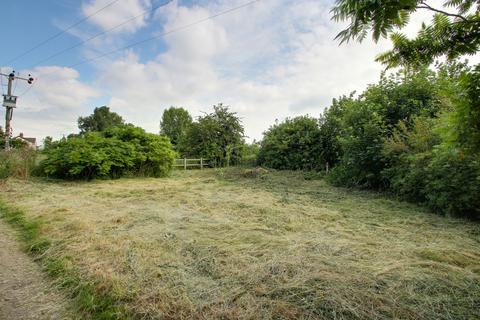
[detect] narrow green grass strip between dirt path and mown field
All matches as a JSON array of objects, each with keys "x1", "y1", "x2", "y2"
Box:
[{"x1": 0, "y1": 200, "x2": 133, "y2": 320}]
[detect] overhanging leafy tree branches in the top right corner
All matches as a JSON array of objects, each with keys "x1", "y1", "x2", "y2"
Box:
[{"x1": 331, "y1": 0, "x2": 480, "y2": 67}]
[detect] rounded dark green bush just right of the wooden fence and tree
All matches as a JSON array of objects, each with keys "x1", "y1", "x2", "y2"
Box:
[{"x1": 258, "y1": 116, "x2": 325, "y2": 170}]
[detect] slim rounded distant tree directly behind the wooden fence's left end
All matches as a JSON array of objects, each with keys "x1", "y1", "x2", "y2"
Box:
[{"x1": 160, "y1": 107, "x2": 192, "y2": 150}]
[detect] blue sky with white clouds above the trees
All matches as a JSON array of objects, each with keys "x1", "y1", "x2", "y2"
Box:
[{"x1": 0, "y1": 0, "x2": 464, "y2": 141}]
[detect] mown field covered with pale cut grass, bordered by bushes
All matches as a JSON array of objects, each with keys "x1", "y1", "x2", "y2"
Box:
[{"x1": 0, "y1": 169, "x2": 480, "y2": 319}]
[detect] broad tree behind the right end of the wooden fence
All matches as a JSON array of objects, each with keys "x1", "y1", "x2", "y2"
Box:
[{"x1": 184, "y1": 103, "x2": 244, "y2": 166}]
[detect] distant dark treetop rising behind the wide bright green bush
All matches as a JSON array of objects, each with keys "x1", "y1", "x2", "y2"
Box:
[{"x1": 78, "y1": 106, "x2": 125, "y2": 134}]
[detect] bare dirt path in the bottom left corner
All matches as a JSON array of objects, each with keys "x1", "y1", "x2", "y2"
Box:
[{"x1": 0, "y1": 219, "x2": 70, "y2": 320}]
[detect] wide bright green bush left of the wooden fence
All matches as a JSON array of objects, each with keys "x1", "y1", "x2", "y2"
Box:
[{"x1": 41, "y1": 125, "x2": 176, "y2": 179}]
